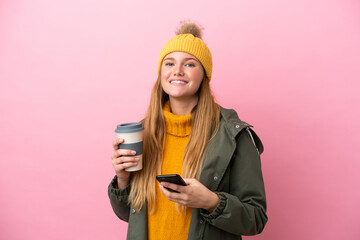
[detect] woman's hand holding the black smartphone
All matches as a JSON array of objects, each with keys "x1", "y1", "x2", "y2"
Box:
[{"x1": 160, "y1": 178, "x2": 219, "y2": 213}]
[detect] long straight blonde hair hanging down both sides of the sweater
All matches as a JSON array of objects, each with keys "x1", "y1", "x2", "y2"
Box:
[{"x1": 129, "y1": 75, "x2": 220, "y2": 212}]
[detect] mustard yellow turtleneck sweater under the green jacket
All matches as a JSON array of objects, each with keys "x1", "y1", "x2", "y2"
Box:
[{"x1": 148, "y1": 102, "x2": 192, "y2": 240}]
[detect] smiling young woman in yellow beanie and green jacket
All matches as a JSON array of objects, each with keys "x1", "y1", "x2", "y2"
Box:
[{"x1": 108, "y1": 23, "x2": 267, "y2": 240}]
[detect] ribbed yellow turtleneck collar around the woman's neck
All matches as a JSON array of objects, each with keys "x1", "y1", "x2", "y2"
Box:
[{"x1": 163, "y1": 102, "x2": 191, "y2": 137}]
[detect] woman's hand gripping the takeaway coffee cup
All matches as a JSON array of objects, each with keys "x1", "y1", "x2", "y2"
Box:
[{"x1": 111, "y1": 138, "x2": 139, "y2": 189}]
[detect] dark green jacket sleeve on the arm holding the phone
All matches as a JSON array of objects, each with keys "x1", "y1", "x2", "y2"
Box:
[{"x1": 200, "y1": 131, "x2": 268, "y2": 235}]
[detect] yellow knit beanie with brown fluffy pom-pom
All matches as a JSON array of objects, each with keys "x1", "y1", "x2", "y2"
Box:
[{"x1": 158, "y1": 23, "x2": 212, "y2": 81}]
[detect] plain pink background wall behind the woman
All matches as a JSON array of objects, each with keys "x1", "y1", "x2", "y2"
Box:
[{"x1": 0, "y1": 0, "x2": 360, "y2": 240}]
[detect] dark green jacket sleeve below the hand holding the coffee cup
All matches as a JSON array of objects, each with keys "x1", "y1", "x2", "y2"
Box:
[{"x1": 108, "y1": 176, "x2": 130, "y2": 222}]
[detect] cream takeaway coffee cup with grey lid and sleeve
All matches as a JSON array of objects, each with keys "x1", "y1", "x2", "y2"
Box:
[{"x1": 115, "y1": 123, "x2": 144, "y2": 172}]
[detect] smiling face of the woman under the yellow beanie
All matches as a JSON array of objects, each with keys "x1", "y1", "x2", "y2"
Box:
[{"x1": 160, "y1": 52, "x2": 204, "y2": 102}]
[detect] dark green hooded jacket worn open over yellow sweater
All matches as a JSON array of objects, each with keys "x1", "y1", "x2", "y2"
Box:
[{"x1": 108, "y1": 107, "x2": 267, "y2": 240}]
